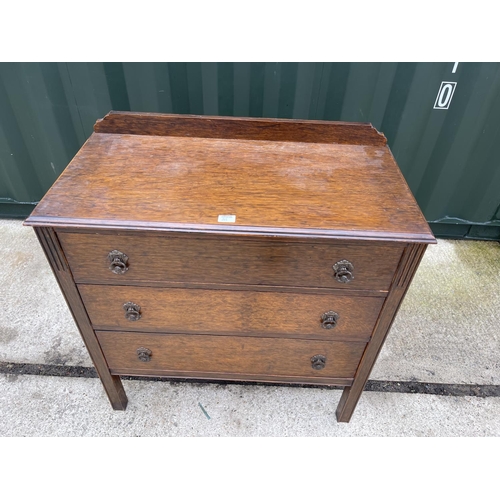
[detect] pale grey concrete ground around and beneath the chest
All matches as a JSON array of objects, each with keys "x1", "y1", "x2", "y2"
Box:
[{"x1": 0, "y1": 220, "x2": 500, "y2": 436}]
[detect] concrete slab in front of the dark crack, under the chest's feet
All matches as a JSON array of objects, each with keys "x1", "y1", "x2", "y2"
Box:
[{"x1": 0, "y1": 375, "x2": 500, "y2": 437}]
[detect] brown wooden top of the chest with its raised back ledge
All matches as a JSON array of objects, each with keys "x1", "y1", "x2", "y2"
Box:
[{"x1": 27, "y1": 113, "x2": 435, "y2": 243}]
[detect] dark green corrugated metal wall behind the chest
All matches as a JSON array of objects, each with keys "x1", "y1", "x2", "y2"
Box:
[{"x1": 0, "y1": 63, "x2": 500, "y2": 239}]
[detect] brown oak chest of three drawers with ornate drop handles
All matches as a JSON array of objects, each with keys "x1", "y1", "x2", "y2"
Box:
[{"x1": 25, "y1": 112, "x2": 435, "y2": 422}]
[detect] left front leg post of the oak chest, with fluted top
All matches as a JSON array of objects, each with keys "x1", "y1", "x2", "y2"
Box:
[{"x1": 35, "y1": 227, "x2": 127, "y2": 410}]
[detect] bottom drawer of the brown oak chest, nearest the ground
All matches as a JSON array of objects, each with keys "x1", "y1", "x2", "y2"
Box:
[{"x1": 97, "y1": 331, "x2": 366, "y2": 385}]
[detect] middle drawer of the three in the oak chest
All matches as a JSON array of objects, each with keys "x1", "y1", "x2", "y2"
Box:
[{"x1": 78, "y1": 285, "x2": 384, "y2": 341}]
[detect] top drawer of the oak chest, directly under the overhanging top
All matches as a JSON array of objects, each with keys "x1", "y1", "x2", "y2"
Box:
[{"x1": 58, "y1": 232, "x2": 403, "y2": 291}]
